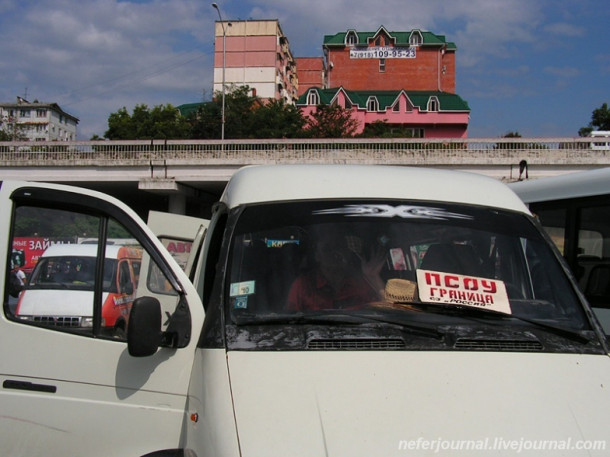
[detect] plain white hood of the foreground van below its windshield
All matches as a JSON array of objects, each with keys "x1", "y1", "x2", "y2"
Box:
[{"x1": 228, "y1": 351, "x2": 610, "y2": 457}]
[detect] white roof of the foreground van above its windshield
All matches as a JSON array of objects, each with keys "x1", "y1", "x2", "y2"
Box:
[{"x1": 221, "y1": 165, "x2": 528, "y2": 213}]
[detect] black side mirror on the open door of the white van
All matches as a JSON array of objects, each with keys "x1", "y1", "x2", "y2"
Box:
[{"x1": 127, "y1": 297, "x2": 162, "y2": 357}]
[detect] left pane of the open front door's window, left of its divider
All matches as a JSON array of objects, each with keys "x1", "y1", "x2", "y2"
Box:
[{"x1": 4, "y1": 206, "x2": 101, "y2": 335}]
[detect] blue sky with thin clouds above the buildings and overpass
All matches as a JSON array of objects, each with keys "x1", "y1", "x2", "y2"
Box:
[{"x1": 0, "y1": 0, "x2": 610, "y2": 140}]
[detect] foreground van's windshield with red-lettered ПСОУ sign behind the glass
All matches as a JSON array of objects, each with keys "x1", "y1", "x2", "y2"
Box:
[{"x1": 226, "y1": 201, "x2": 591, "y2": 350}]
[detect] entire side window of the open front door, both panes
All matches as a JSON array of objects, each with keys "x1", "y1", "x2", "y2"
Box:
[{"x1": 4, "y1": 205, "x2": 177, "y2": 341}]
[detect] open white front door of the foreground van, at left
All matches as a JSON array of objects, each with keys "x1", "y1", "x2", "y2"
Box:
[{"x1": 0, "y1": 182, "x2": 203, "y2": 456}]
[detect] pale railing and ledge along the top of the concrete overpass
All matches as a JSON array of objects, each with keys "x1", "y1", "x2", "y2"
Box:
[{"x1": 0, "y1": 138, "x2": 610, "y2": 167}]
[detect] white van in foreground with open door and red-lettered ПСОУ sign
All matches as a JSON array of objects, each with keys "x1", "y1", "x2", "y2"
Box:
[{"x1": 0, "y1": 165, "x2": 610, "y2": 457}]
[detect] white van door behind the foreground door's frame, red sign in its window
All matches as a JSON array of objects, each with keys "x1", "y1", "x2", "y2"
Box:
[{"x1": 147, "y1": 211, "x2": 210, "y2": 280}]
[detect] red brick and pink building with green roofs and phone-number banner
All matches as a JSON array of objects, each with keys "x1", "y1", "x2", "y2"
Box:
[{"x1": 297, "y1": 27, "x2": 470, "y2": 138}]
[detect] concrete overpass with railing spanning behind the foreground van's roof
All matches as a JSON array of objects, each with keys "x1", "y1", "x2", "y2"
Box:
[{"x1": 0, "y1": 138, "x2": 610, "y2": 216}]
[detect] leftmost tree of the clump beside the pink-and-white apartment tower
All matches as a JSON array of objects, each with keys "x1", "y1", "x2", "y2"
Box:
[{"x1": 104, "y1": 104, "x2": 191, "y2": 140}]
